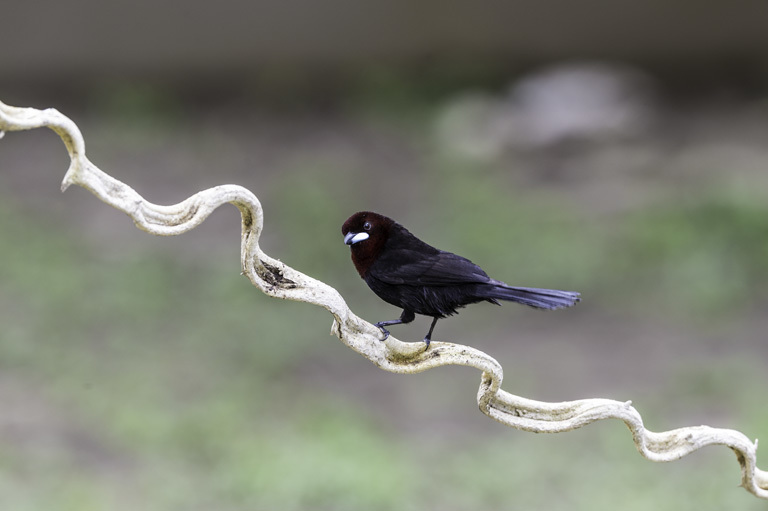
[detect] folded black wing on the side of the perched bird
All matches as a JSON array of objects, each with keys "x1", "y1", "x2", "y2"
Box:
[{"x1": 372, "y1": 248, "x2": 490, "y2": 286}]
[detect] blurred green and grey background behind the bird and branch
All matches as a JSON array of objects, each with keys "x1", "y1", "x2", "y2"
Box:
[{"x1": 0, "y1": 0, "x2": 768, "y2": 511}]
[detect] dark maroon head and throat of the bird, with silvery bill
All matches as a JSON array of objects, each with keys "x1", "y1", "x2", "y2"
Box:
[{"x1": 341, "y1": 211, "x2": 395, "y2": 278}]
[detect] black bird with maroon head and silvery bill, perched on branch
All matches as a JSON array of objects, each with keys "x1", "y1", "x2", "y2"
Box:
[{"x1": 341, "y1": 211, "x2": 581, "y2": 348}]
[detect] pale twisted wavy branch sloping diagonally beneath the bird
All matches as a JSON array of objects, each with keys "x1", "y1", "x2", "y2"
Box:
[{"x1": 0, "y1": 102, "x2": 768, "y2": 499}]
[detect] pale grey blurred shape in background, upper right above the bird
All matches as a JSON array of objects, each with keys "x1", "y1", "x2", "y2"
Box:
[{"x1": 435, "y1": 63, "x2": 655, "y2": 160}]
